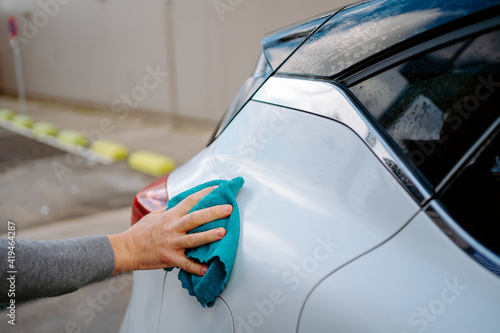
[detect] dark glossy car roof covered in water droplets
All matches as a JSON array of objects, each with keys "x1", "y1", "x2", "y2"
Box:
[{"x1": 279, "y1": 0, "x2": 498, "y2": 78}]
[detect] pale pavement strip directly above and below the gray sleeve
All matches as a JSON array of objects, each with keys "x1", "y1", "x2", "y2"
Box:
[{"x1": 0, "y1": 207, "x2": 132, "y2": 333}]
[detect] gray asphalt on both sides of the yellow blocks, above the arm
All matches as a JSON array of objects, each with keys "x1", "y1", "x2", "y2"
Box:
[{"x1": 0, "y1": 96, "x2": 211, "y2": 229}]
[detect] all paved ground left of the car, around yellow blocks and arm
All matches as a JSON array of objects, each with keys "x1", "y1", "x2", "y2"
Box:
[{"x1": 0, "y1": 96, "x2": 211, "y2": 333}]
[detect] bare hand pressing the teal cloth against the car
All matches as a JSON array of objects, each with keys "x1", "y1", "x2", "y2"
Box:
[{"x1": 108, "y1": 186, "x2": 233, "y2": 275}]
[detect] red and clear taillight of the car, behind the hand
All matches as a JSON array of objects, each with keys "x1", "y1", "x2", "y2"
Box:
[{"x1": 131, "y1": 175, "x2": 168, "y2": 225}]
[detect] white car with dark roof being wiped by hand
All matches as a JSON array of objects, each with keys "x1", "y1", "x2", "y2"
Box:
[{"x1": 121, "y1": 0, "x2": 500, "y2": 333}]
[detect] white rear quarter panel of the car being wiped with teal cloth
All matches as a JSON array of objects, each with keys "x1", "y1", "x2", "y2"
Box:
[{"x1": 165, "y1": 101, "x2": 419, "y2": 331}]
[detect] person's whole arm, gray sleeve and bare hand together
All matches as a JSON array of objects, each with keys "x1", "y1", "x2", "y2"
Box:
[{"x1": 0, "y1": 186, "x2": 233, "y2": 303}]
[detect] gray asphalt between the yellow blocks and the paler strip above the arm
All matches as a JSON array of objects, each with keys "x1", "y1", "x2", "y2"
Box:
[{"x1": 0, "y1": 129, "x2": 155, "y2": 230}]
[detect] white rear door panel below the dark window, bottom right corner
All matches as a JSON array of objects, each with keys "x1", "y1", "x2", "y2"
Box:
[{"x1": 298, "y1": 212, "x2": 500, "y2": 333}]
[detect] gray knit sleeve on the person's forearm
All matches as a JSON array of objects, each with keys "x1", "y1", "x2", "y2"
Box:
[{"x1": 0, "y1": 236, "x2": 115, "y2": 303}]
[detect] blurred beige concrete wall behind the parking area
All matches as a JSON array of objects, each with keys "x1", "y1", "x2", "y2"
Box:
[{"x1": 0, "y1": 0, "x2": 352, "y2": 122}]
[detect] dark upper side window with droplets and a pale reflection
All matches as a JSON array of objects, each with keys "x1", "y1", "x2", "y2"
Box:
[{"x1": 350, "y1": 31, "x2": 500, "y2": 186}]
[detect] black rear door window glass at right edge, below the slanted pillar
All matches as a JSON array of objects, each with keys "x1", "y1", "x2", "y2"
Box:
[{"x1": 440, "y1": 129, "x2": 500, "y2": 255}]
